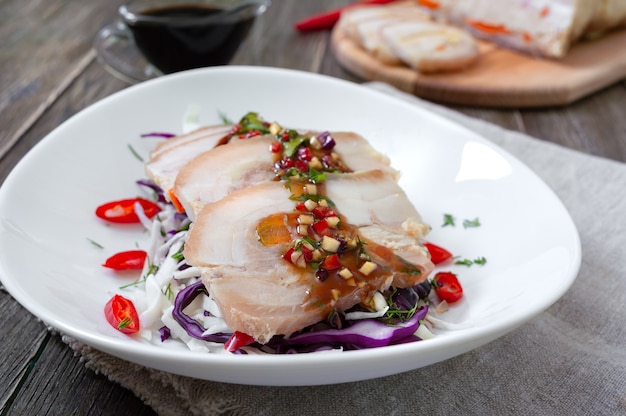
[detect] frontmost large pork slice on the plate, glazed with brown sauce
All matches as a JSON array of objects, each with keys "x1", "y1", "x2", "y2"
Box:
[{"x1": 184, "y1": 171, "x2": 433, "y2": 343}]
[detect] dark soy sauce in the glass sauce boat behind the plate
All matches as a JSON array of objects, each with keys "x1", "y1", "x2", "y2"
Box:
[{"x1": 128, "y1": 5, "x2": 254, "y2": 74}]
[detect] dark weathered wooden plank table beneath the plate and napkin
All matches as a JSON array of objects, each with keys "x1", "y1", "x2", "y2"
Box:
[{"x1": 0, "y1": 0, "x2": 626, "y2": 415}]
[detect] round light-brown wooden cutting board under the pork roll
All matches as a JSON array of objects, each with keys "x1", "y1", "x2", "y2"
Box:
[{"x1": 331, "y1": 26, "x2": 626, "y2": 108}]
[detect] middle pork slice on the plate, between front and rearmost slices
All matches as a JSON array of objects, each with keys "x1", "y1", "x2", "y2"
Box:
[{"x1": 173, "y1": 132, "x2": 391, "y2": 221}]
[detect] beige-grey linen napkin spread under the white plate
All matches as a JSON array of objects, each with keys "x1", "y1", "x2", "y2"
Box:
[{"x1": 65, "y1": 83, "x2": 626, "y2": 416}]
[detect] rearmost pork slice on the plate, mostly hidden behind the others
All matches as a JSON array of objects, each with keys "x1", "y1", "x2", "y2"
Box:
[{"x1": 145, "y1": 124, "x2": 232, "y2": 197}]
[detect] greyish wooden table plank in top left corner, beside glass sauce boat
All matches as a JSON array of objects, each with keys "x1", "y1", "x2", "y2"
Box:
[{"x1": 0, "y1": 0, "x2": 121, "y2": 156}]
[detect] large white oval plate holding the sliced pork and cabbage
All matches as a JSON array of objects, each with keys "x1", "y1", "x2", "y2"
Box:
[{"x1": 0, "y1": 67, "x2": 580, "y2": 385}]
